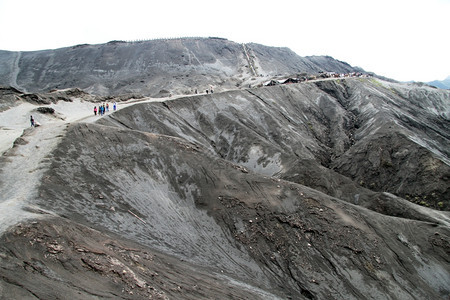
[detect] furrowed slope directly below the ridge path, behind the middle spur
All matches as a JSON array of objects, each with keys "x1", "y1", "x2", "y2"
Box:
[{"x1": 101, "y1": 79, "x2": 450, "y2": 210}]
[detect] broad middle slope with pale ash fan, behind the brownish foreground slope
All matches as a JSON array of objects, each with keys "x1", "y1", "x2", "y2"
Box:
[{"x1": 27, "y1": 119, "x2": 449, "y2": 299}]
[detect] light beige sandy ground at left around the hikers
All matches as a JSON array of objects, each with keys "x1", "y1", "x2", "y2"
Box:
[{"x1": 0, "y1": 98, "x2": 174, "y2": 233}]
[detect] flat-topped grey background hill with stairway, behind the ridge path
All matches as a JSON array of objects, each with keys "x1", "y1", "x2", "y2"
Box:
[{"x1": 0, "y1": 38, "x2": 361, "y2": 96}]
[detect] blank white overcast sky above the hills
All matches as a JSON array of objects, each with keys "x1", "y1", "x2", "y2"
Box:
[{"x1": 0, "y1": 0, "x2": 450, "y2": 81}]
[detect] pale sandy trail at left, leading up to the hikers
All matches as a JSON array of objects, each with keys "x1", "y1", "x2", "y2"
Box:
[{"x1": 0, "y1": 95, "x2": 163, "y2": 233}]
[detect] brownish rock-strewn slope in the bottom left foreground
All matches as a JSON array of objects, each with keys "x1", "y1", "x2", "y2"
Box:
[{"x1": 0, "y1": 218, "x2": 278, "y2": 299}]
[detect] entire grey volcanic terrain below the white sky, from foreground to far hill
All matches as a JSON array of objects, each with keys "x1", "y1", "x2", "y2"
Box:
[{"x1": 0, "y1": 38, "x2": 450, "y2": 299}]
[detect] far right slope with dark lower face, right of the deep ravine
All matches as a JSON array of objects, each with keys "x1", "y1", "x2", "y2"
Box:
[{"x1": 318, "y1": 81, "x2": 450, "y2": 206}]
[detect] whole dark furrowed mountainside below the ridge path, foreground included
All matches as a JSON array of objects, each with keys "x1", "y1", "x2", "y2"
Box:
[{"x1": 0, "y1": 79, "x2": 450, "y2": 299}]
